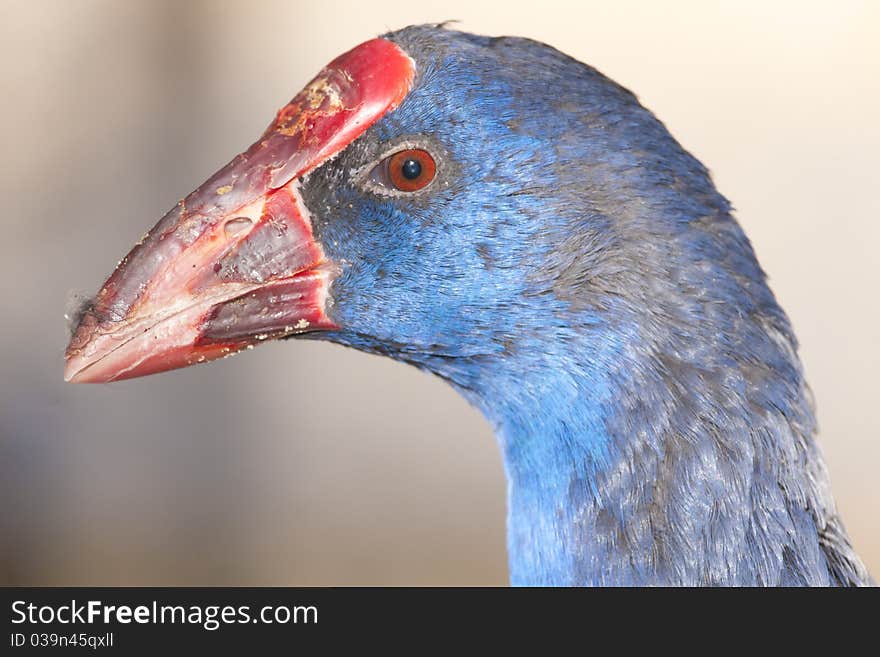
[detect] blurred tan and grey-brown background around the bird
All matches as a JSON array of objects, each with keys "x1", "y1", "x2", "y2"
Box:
[{"x1": 0, "y1": 0, "x2": 880, "y2": 584}]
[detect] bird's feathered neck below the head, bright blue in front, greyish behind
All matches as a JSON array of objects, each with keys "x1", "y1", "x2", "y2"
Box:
[{"x1": 433, "y1": 300, "x2": 833, "y2": 585}]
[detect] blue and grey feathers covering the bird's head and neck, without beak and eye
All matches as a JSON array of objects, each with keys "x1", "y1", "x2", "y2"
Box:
[{"x1": 301, "y1": 26, "x2": 869, "y2": 585}]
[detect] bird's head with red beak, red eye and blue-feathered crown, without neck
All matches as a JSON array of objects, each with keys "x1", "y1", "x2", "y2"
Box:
[{"x1": 65, "y1": 26, "x2": 764, "y2": 426}]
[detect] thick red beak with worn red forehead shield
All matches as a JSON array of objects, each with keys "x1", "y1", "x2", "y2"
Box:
[{"x1": 64, "y1": 39, "x2": 414, "y2": 383}]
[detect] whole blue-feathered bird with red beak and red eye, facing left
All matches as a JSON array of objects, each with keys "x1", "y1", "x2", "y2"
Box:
[{"x1": 65, "y1": 24, "x2": 873, "y2": 586}]
